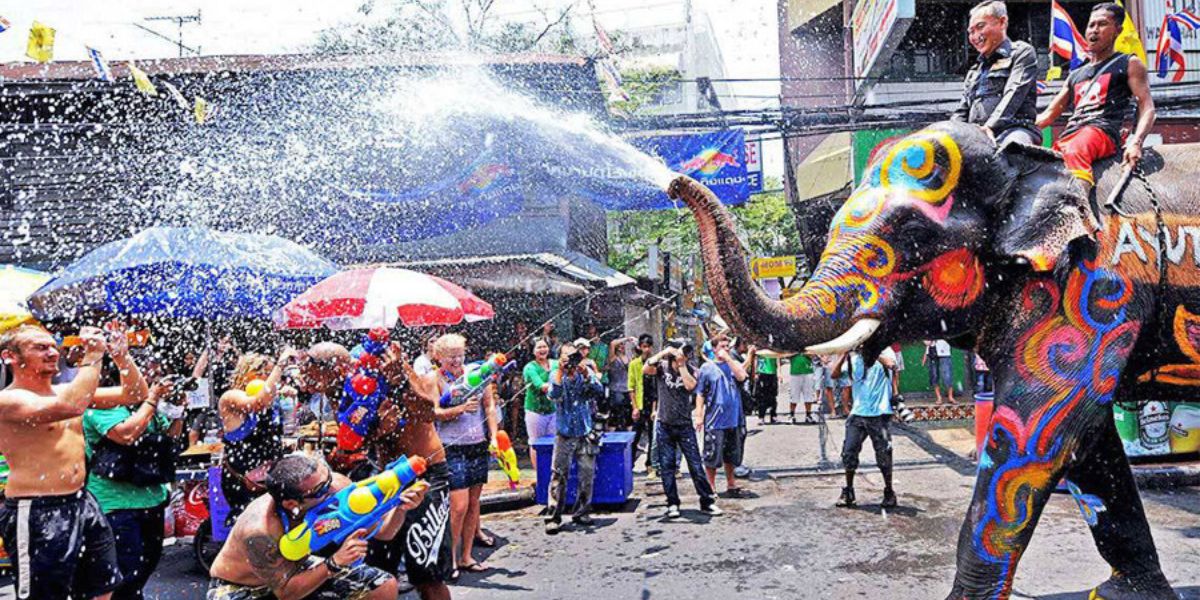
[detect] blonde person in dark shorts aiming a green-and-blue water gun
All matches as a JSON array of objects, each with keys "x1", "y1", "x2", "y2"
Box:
[{"x1": 433, "y1": 334, "x2": 497, "y2": 578}]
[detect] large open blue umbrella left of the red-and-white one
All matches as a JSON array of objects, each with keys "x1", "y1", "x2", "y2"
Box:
[{"x1": 29, "y1": 227, "x2": 337, "y2": 320}]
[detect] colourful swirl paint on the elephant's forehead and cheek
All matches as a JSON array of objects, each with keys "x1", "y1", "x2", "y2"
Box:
[{"x1": 788, "y1": 127, "x2": 991, "y2": 328}]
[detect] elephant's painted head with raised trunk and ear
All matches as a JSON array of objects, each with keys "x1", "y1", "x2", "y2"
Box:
[{"x1": 667, "y1": 122, "x2": 1086, "y2": 355}]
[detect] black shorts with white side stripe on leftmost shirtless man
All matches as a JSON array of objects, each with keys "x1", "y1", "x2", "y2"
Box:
[{"x1": 0, "y1": 490, "x2": 121, "y2": 600}]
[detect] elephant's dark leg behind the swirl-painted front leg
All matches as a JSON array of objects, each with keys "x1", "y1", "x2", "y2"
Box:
[{"x1": 1067, "y1": 418, "x2": 1177, "y2": 600}]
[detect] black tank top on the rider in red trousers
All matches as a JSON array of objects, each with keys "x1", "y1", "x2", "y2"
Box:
[{"x1": 1063, "y1": 53, "x2": 1133, "y2": 148}]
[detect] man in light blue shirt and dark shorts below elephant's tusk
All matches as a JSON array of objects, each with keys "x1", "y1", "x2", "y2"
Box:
[{"x1": 833, "y1": 348, "x2": 896, "y2": 509}]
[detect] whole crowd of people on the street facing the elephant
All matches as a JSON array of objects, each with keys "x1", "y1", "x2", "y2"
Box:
[{"x1": 0, "y1": 304, "x2": 974, "y2": 600}]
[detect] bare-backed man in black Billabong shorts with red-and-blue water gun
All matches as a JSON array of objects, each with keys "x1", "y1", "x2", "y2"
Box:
[{"x1": 300, "y1": 342, "x2": 454, "y2": 600}]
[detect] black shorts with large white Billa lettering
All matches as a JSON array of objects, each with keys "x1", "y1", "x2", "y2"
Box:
[{"x1": 367, "y1": 462, "x2": 454, "y2": 586}]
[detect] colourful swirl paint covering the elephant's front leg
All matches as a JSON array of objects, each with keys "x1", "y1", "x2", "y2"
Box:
[{"x1": 974, "y1": 262, "x2": 1140, "y2": 598}]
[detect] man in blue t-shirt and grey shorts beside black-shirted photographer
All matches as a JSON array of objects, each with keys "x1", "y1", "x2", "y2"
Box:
[{"x1": 695, "y1": 332, "x2": 748, "y2": 498}]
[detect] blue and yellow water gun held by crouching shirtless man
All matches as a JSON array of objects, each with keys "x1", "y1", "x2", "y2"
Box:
[{"x1": 280, "y1": 456, "x2": 426, "y2": 562}]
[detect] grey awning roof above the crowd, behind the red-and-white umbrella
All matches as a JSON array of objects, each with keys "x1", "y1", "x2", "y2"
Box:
[{"x1": 376, "y1": 251, "x2": 636, "y2": 295}]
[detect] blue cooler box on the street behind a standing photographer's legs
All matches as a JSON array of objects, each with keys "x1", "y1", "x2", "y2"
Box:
[{"x1": 533, "y1": 431, "x2": 634, "y2": 512}]
